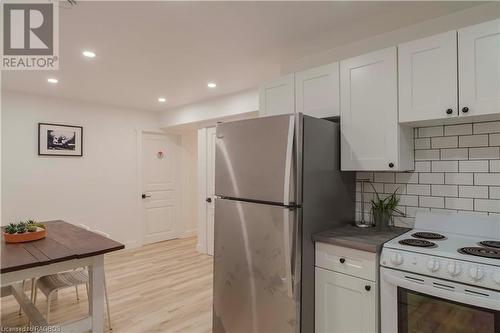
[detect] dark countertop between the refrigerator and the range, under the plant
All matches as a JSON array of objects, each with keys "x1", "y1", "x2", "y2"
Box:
[{"x1": 312, "y1": 224, "x2": 410, "y2": 253}]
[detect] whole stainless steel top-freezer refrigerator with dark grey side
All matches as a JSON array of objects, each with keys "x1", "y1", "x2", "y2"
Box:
[{"x1": 213, "y1": 114, "x2": 355, "y2": 333}]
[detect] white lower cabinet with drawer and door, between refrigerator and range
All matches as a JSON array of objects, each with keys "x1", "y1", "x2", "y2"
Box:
[{"x1": 314, "y1": 243, "x2": 379, "y2": 333}]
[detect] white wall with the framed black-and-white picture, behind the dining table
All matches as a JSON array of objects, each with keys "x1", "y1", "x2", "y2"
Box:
[{"x1": 2, "y1": 92, "x2": 162, "y2": 246}]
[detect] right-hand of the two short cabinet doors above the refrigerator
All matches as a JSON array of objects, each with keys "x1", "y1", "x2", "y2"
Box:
[{"x1": 295, "y1": 62, "x2": 340, "y2": 118}]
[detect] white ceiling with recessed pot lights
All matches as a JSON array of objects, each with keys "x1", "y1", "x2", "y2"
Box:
[{"x1": 2, "y1": 1, "x2": 478, "y2": 111}]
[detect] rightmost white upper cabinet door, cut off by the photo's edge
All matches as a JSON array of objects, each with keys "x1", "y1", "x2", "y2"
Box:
[{"x1": 458, "y1": 19, "x2": 500, "y2": 116}]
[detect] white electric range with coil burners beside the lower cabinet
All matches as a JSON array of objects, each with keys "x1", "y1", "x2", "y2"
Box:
[{"x1": 380, "y1": 212, "x2": 500, "y2": 333}]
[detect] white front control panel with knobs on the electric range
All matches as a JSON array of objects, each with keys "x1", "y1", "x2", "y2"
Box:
[{"x1": 380, "y1": 248, "x2": 500, "y2": 290}]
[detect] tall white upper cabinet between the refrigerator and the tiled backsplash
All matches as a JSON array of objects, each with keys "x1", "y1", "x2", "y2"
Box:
[{"x1": 340, "y1": 47, "x2": 413, "y2": 170}]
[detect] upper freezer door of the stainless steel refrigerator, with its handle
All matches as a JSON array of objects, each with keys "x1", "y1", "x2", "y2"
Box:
[{"x1": 215, "y1": 115, "x2": 295, "y2": 205}]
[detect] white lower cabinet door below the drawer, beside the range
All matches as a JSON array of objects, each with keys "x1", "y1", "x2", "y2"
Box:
[{"x1": 315, "y1": 267, "x2": 378, "y2": 333}]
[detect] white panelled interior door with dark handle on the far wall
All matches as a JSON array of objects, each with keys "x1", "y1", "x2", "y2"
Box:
[{"x1": 141, "y1": 133, "x2": 179, "y2": 244}]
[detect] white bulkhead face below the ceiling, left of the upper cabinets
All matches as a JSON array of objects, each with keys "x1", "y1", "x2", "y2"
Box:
[{"x1": 160, "y1": 89, "x2": 259, "y2": 128}]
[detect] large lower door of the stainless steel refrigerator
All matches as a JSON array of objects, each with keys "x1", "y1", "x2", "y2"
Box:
[{"x1": 213, "y1": 199, "x2": 300, "y2": 333}]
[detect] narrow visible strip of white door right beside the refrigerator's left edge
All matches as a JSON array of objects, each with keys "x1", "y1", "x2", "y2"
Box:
[{"x1": 206, "y1": 127, "x2": 215, "y2": 255}]
